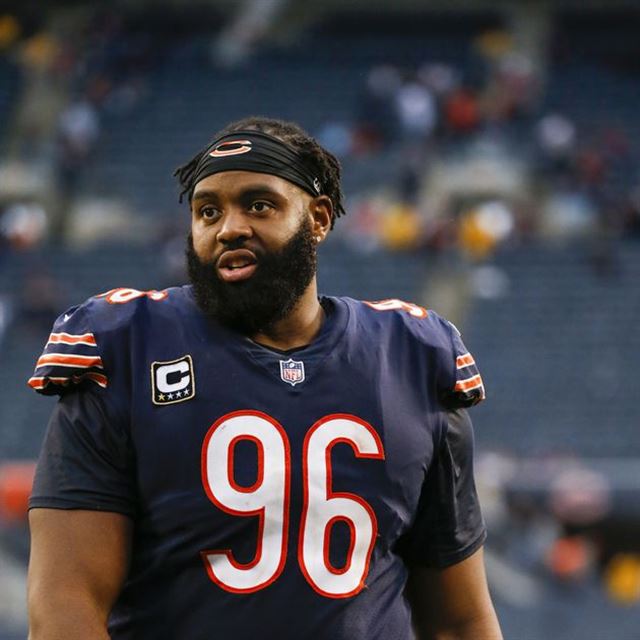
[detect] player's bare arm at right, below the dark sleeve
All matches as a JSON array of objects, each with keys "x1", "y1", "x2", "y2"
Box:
[{"x1": 407, "y1": 549, "x2": 502, "y2": 640}]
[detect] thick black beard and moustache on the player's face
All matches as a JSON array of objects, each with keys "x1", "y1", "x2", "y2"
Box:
[{"x1": 186, "y1": 218, "x2": 317, "y2": 336}]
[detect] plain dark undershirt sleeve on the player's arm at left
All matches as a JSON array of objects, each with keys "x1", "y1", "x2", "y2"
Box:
[{"x1": 29, "y1": 385, "x2": 136, "y2": 517}]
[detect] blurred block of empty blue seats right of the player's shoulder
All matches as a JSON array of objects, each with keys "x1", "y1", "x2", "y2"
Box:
[{"x1": 465, "y1": 243, "x2": 640, "y2": 457}]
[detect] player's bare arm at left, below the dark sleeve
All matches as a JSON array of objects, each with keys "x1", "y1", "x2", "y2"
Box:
[{"x1": 28, "y1": 509, "x2": 132, "y2": 640}]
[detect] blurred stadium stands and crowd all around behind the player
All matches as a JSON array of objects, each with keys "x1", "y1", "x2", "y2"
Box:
[{"x1": 0, "y1": 0, "x2": 640, "y2": 640}]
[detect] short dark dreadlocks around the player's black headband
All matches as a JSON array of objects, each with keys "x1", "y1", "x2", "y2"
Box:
[{"x1": 173, "y1": 116, "x2": 346, "y2": 229}]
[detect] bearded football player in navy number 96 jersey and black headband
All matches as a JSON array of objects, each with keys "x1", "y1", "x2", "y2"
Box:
[{"x1": 29, "y1": 118, "x2": 500, "y2": 640}]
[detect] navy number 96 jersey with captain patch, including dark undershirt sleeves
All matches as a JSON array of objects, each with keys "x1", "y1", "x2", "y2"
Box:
[{"x1": 29, "y1": 286, "x2": 485, "y2": 640}]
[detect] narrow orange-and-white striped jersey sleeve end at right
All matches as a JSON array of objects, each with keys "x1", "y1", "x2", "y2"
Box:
[{"x1": 441, "y1": 320, "x2": 486, "y2": 410}]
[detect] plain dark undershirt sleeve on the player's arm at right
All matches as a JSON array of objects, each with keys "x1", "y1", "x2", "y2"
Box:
[{"x1": 399, "y1": 409, "x2": 486, "y2": 568}]
